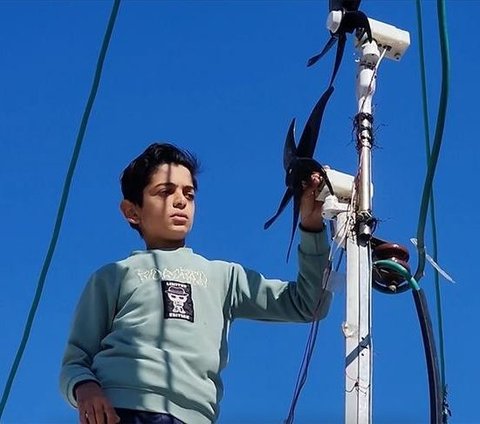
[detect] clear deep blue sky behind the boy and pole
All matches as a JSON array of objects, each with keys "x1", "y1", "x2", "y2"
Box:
[{"x1": 0, "y1": 0, "x2": 480, "y2": 424}]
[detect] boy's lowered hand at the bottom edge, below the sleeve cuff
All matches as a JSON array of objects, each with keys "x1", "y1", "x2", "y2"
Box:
[{"x1": 75, "y1": 381, "x2": 120, "y2": 424}]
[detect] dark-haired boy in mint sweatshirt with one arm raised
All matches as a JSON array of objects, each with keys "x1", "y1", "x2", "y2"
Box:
[{"x1": 60, "y1": 143, "x2": 331, "y2": 424}]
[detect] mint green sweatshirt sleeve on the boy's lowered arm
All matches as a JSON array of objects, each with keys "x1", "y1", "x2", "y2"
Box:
[{"x1": 60, "y1": 265, "x2": 117, "y2": 407}]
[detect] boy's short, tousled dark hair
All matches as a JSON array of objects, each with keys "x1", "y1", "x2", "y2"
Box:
[{"x1": 120, "y1": 143, "x2": 199, "y2": 208}]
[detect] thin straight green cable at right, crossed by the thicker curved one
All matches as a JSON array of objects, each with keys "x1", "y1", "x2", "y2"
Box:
[{"x1": 416, "y1": 0, "x2": 446, "y2": 410}]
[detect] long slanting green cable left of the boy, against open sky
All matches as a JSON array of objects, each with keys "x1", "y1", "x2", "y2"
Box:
[{"x1": 0, "y1": 0, "x2": 120, "y2": 419}]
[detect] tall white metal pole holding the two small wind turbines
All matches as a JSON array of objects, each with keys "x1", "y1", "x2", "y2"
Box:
[{"x1": 343, "y1": 42, "x2": 380, "y2": 424}]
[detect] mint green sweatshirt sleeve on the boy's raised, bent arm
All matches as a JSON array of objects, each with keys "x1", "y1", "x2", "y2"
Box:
[{"x1": 232, "y1": 230, "x2": 332, "y2": 322}]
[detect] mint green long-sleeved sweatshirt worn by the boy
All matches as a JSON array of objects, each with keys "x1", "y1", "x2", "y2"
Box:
[{"x1": 60, "y1": 231, "x2": 332, "y2": 424}]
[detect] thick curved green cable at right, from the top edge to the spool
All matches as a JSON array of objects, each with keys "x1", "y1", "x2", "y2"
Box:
[{"x1": 414, "y1": 0, "x2": 450, "y2": 281}]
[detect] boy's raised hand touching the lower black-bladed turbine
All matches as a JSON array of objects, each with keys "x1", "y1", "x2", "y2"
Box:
[{"x1": 300, "y1": 172, "x2": 324, "y2": 232}]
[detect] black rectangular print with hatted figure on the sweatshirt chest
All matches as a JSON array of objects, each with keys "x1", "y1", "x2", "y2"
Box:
[{"x1": 162, "y1": 280, "x2": 193, "y2": 322}]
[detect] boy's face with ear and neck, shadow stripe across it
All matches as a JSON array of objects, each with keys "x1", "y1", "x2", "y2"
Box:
[{"x1": 121, "y1": 163, "x2": 195, "y2": 249}]
